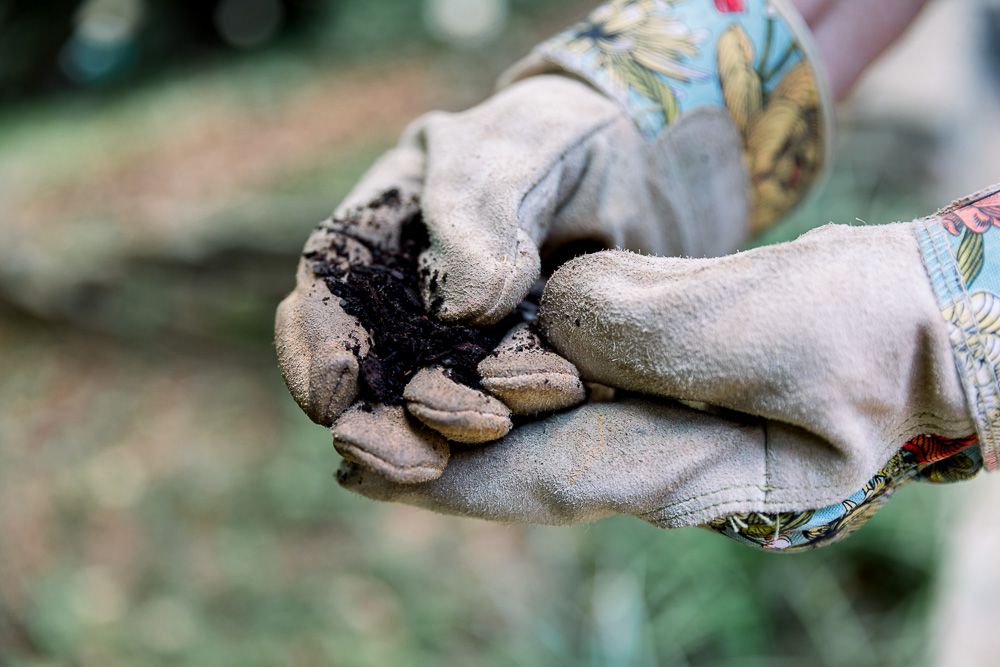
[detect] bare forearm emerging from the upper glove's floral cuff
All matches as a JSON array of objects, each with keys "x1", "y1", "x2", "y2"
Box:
[{"x1": 793, "y1": 0, "x2": 927, "y2": 99}]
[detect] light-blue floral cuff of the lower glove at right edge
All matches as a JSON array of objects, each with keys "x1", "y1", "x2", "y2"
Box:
[{"x1": 917, "y1": 185, "x2": 1000, "y2": 471}]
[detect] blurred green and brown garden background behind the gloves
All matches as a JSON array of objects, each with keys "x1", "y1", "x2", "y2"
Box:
[{"x1": 0, "y1": 0, "x2": 988, "y2": 667}]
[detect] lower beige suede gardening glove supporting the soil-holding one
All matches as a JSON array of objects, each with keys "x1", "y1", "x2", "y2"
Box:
[{"x1": 341, "y1": 186, "x2": 1000, "y2": 549}]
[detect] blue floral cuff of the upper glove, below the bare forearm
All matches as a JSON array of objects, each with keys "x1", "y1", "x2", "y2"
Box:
[{"x1": 499, "y1": 0, "x2": 833, "y2": 230}]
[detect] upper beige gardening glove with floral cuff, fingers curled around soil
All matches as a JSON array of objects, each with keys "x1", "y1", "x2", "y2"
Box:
[{"x1": 276, "y1": 0, "x2": 831, "y2": 481}]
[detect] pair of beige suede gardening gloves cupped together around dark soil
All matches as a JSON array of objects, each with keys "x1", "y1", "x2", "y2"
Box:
[{"x1": 276, "y1": 0, "x2": 988, "y2": 548}]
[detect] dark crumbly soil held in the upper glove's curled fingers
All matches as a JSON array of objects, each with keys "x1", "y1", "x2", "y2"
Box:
[{"x1": 305, "y1": 192, "x2": 523, "y2": 405}]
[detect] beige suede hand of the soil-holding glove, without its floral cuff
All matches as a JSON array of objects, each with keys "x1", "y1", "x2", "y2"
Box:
[{"x1": 276, "y1": 76, "x2": 747, "y2": 482}]
